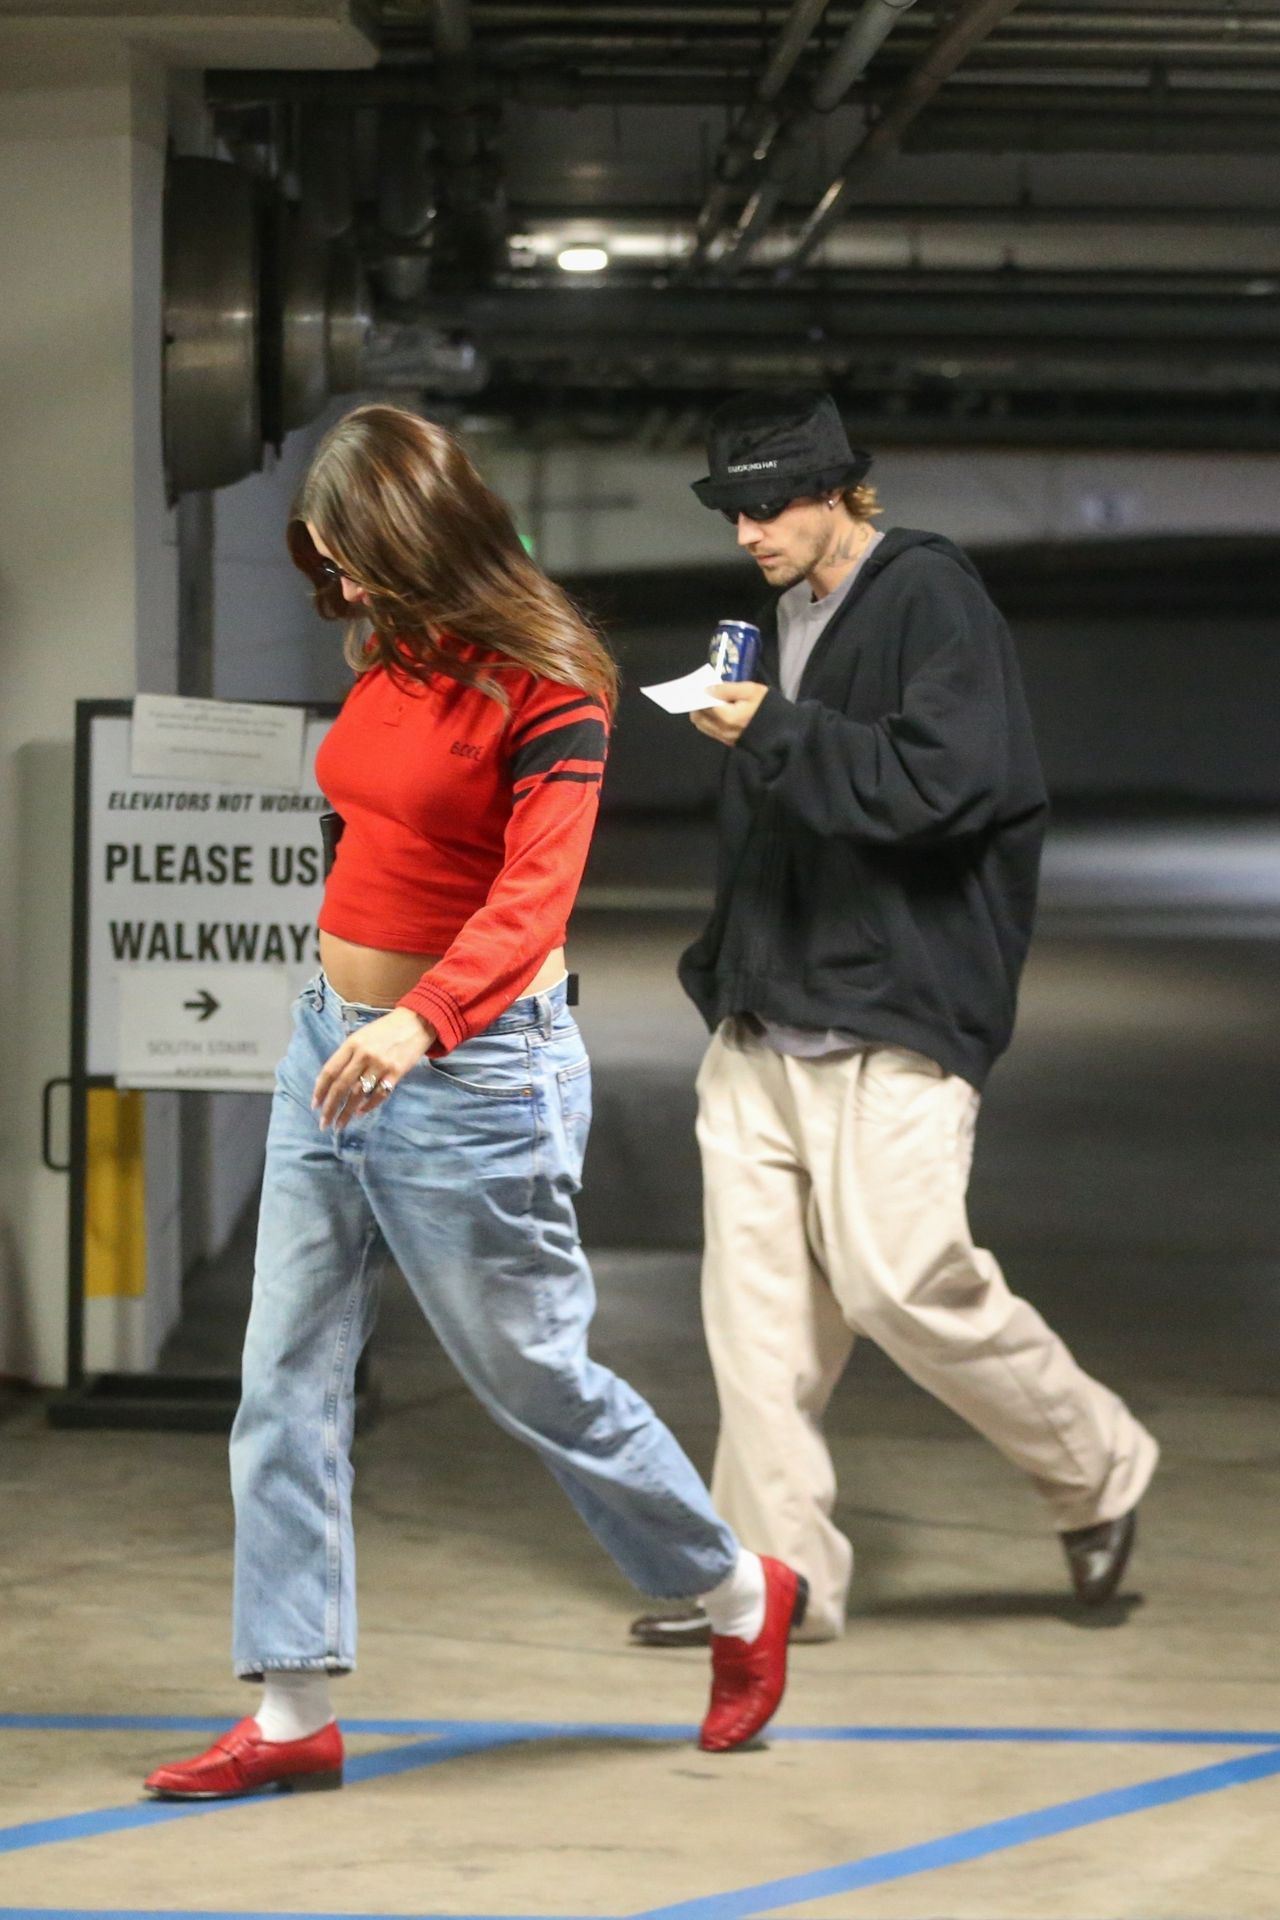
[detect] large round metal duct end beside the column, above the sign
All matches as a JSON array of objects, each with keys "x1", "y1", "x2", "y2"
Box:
[{"x1": 163, "y1": 157, "x2": 370, "y2": 499}]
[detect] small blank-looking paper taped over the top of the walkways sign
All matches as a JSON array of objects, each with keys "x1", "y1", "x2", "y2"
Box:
[{"x1": 129, "y1": 693, "x2": 307, "y2": 793}]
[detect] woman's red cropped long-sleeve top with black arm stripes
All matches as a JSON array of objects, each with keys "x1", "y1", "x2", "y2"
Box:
[{"x1": 315, "y1": 643, "x2": 608, "y2": 1054}]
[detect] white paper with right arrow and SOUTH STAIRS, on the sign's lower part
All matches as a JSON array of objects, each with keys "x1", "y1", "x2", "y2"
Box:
[{"x1": 115, "y1": 966, "x2": 294, "y2": 1092}]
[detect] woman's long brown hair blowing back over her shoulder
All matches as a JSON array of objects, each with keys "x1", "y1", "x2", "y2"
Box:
[{"x1": 288, "y1": 405, "x2": 618, "y2": 708}]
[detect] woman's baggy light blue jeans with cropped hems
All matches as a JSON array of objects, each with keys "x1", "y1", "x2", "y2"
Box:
[{"x1": 230, "y1": 973, "x2": 737, "y2": 1678}]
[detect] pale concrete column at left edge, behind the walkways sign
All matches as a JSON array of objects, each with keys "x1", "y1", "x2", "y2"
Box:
[{"x1": 0, "y1": 42, "x2": 177, "y2": 1382}]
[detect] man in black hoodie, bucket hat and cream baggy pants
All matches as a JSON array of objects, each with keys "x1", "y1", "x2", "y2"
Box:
[{"x1": 631, "y1": 394, "x2": 1157, "y2": 1645}]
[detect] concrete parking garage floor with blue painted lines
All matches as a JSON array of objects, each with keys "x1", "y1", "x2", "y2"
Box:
[{"x1": 0, "y1": 916, "x2": 1280, "y2": 1920}]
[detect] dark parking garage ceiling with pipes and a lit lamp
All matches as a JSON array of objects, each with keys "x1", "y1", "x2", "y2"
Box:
[{"x1": 207, "y1": 0, "x2": 1280, "y2": 449}]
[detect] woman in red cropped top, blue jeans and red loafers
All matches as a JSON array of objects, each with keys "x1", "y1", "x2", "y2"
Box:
[{"x1": 146, "y1": 405, "x2": 804, "y2": 1799}]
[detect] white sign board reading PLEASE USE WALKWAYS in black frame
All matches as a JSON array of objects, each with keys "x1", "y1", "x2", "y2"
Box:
[{"x1": 86, "y1": 708, "x2": 332, "y2": 1085}]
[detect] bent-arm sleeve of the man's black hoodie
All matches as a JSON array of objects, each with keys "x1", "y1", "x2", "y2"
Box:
[{"x1": 735, "y1": 564, "x2": 1009, "y2": 845}]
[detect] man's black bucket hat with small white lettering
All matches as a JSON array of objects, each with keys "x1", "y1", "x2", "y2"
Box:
[{"x1": 693, "y1": 388, "x2": 871, "y2": 511}]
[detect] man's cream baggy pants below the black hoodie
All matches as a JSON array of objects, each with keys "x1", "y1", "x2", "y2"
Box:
[{"x1": 699, "y1": 1021, "x2": 1159, "y2": 1640}]
